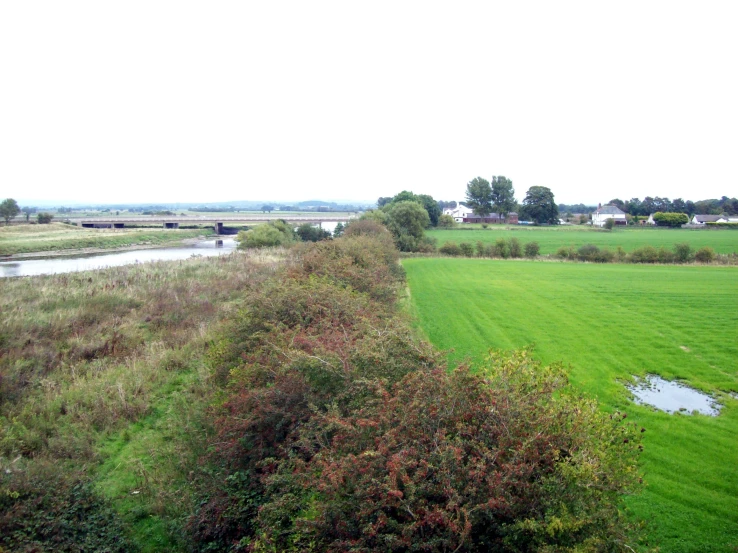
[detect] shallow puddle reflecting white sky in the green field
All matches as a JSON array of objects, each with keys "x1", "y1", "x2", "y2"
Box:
[{"x1": 627, "y1": 374, "x2": 722, "y2": 417}]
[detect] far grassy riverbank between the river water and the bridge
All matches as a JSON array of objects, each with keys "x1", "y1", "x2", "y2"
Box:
[{"x1": 0, "y1": 223, "x2": 214, "y2": 261}]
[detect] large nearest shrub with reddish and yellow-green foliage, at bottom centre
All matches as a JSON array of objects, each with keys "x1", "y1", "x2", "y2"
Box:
[{"x1": 252, "y1": 351, "x2": 640, "y2": 553}]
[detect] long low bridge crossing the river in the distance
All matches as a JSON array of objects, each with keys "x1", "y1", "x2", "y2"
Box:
[{"x1": 65, "y1": 213, "x2": 352, "y2": 234}]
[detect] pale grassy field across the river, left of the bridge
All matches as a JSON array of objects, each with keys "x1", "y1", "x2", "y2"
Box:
[{"x1": 0, "y1": 223, "x2": 213, "y2": 255}]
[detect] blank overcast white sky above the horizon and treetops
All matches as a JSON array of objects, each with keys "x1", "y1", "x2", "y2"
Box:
[{"x1": 0, "y1": 0, "x2": 738, "y2": 203}]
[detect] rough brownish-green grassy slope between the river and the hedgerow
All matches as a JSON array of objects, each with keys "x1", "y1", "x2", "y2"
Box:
[{"x1": 0, "y1": 252, "x2": 275, "y2": 552}]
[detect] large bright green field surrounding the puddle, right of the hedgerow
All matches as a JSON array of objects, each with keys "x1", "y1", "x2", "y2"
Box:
[{"x1": 403, "y1": 258, "x2": 738, "y2": 553}]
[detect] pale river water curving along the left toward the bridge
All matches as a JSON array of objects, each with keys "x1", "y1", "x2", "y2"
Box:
[{"x1": 0, "y1": 238, "x2": 236, "y2": 278}]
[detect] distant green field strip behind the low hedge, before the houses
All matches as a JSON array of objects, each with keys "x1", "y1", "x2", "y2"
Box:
[{"x1": 427, "y1": 225, "x2": 738, "y2": 255}]
